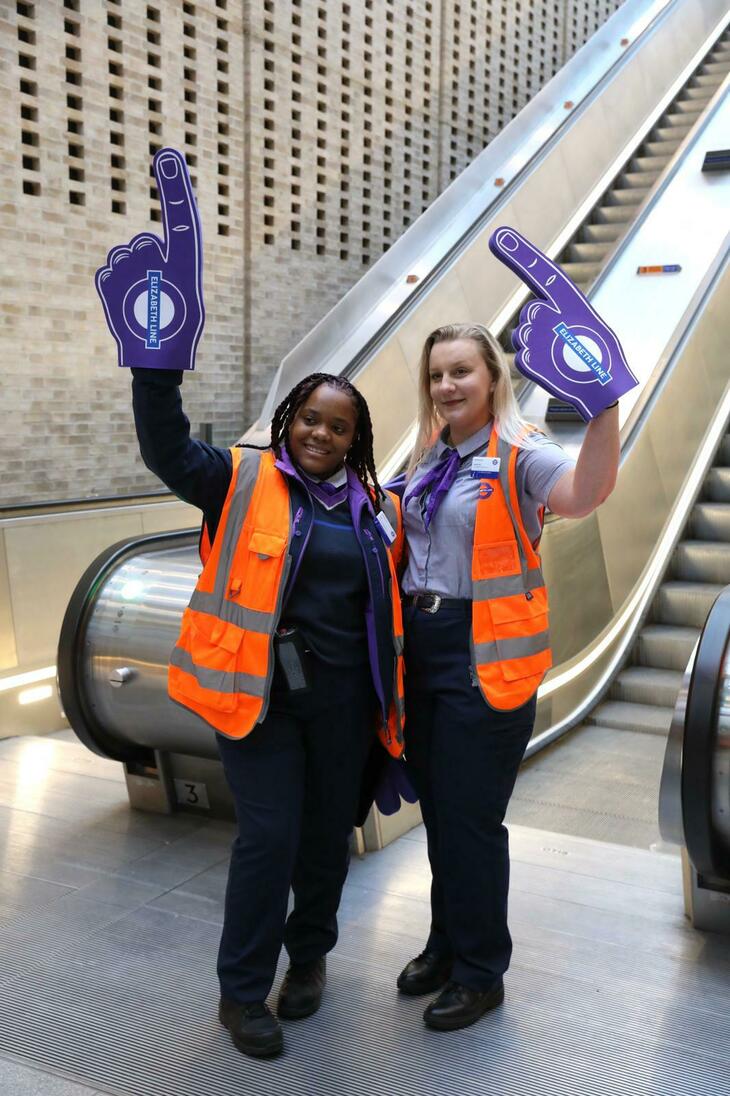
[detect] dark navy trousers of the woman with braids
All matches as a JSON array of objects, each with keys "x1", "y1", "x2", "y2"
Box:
[{"x1": 217, "y1": 661, "x2": 375, "y2": 1003}]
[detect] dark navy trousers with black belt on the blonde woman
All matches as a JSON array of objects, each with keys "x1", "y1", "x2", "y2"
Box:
[{"x1": 403, "y1": 605, "x2": 535, "y2": 991}]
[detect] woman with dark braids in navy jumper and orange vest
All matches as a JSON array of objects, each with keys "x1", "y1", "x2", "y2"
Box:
[{"x1": 133, "y1": 369, "x2": 403, "y2": 1058}]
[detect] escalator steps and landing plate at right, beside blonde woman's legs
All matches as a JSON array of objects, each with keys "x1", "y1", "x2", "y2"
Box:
[{"x1": 507, "y1": 423, "x2": 730, "y2": 848}]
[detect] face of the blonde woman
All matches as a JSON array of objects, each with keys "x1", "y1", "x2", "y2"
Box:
[{"x1": 429, "y1": 339, "x2": 495, "y2": 445}]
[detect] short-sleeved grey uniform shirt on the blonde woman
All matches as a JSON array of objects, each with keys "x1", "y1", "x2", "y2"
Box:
[{"x1": 402, "y1": 422, "x2": 574, "y2": 598}]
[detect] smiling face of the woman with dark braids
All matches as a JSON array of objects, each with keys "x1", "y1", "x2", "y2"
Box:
[{"x1": 288, "y1": 385, "x2": 357, "y2": 479}]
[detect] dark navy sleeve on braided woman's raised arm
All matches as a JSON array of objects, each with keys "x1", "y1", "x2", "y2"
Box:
[{"x1": 132, "y1": 369, "x2": 232, "y2": 539}]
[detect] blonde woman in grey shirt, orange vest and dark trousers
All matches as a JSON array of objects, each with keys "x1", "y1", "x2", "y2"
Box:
[{"x1": 398, "y1": 324, "x2": 619, "y2": 1030}]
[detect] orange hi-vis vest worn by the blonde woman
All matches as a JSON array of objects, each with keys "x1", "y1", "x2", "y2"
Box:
[{"x1": 471, "y1": 424, "x2": 552, "y2": 711}]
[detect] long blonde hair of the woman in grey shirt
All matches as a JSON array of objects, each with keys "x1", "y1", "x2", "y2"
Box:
[{"x1": 408, "y1": 323, "x2": 533, "y2": 476}]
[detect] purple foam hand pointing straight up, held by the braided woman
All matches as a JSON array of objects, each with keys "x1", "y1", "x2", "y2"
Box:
[{"x1": 95, "y1": 148, "x2": 205, "y2": 369}]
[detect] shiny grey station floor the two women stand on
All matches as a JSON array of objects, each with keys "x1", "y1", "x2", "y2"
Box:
[{"x1": 0, "y1": 739, "x2": 730, "y2": 1096}]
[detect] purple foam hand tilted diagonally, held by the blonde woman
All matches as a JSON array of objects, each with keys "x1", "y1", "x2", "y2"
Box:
[{"x1": 489, "y1": 226, "x2": 638, "y2": 422}]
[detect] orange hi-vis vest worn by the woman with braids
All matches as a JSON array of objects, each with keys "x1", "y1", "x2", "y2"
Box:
[{"x1": 168, "y1": 446, "x2": 403, "y2": 757}]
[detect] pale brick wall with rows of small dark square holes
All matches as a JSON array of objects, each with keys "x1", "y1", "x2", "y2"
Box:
[{"x1": 0, "y1": 0, "x2": 619, "y2": 505}]
